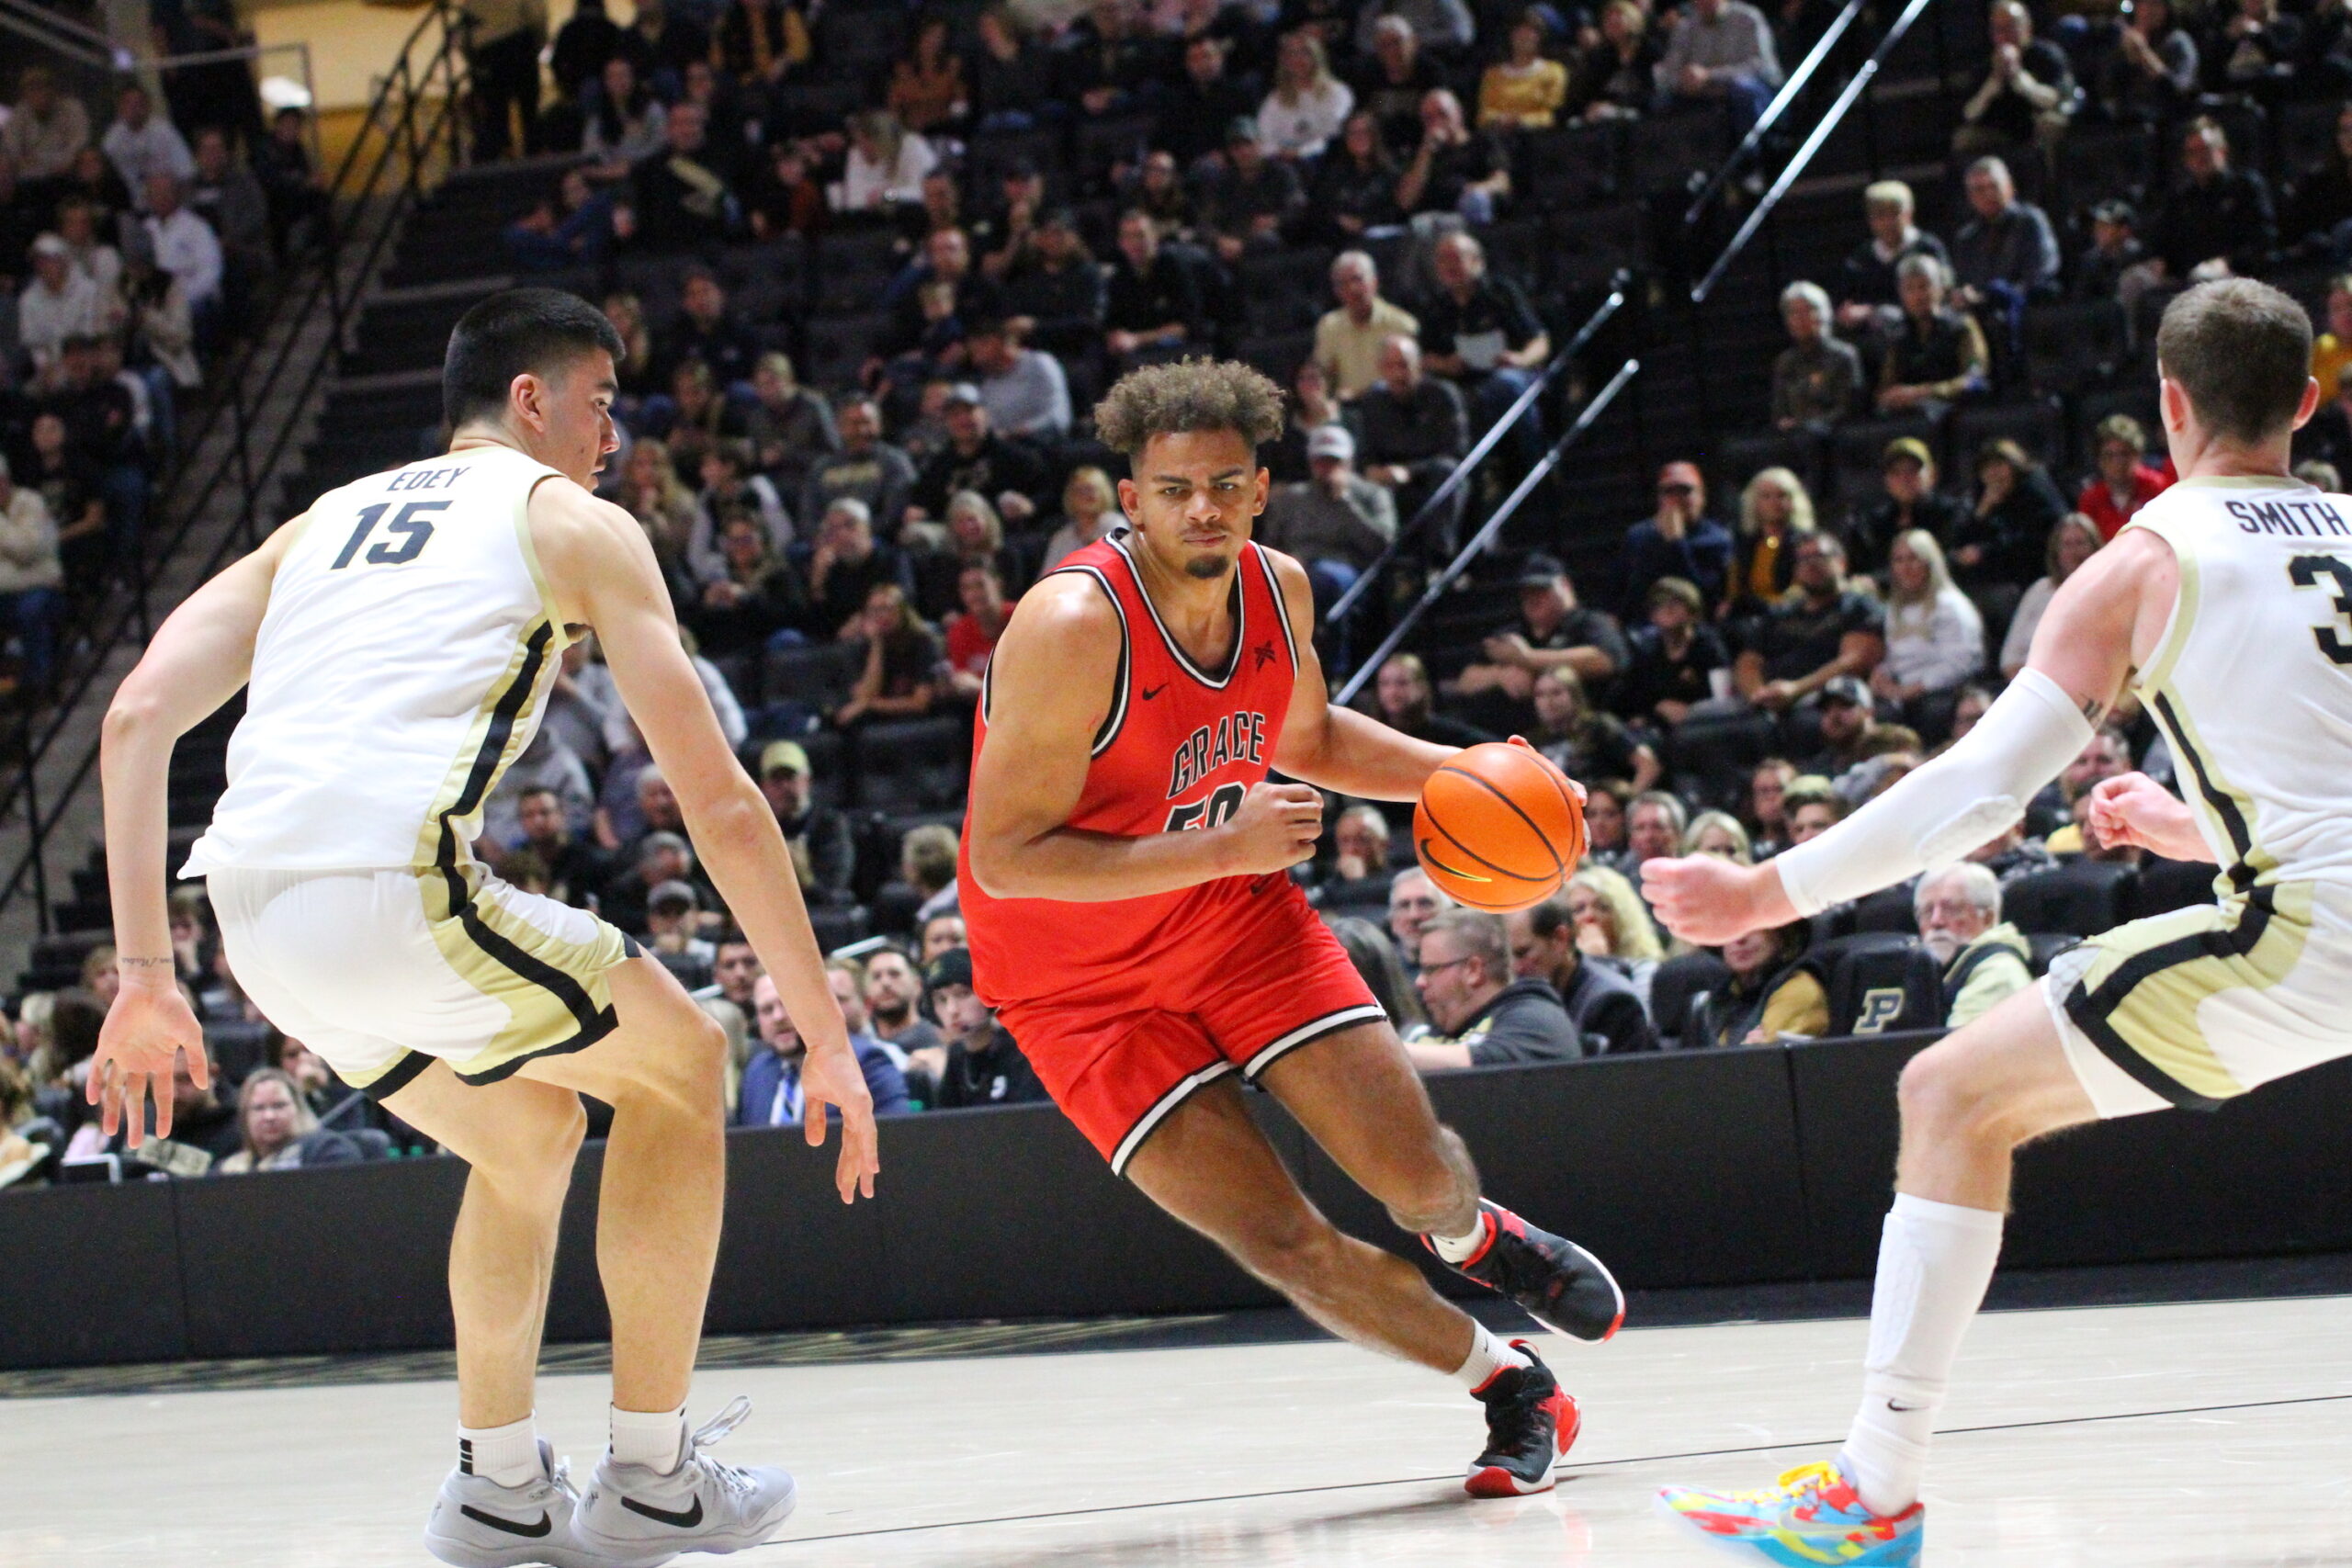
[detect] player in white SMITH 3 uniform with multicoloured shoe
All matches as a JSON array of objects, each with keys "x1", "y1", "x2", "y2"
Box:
[{"x1": 1644, "y1": 280, "x2": 2352, "y2": 1568}]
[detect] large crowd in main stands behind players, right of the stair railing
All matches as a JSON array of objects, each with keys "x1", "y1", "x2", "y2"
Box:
[{"x1": 18, "y1": 0, "x2": 2352, "y2": 1189}]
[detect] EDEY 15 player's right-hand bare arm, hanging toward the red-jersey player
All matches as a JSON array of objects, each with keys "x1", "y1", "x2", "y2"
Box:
[{"x1": 532, "y1": 479, "x2": 879, "y2": 1203}]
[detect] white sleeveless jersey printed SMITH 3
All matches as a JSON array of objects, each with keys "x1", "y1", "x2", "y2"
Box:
[{"x1": 2131, "y1": 478, "x2": 2352, "y2": 894}]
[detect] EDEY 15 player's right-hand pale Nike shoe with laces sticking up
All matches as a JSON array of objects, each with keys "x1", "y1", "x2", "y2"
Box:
[{"x1": 571, "y1": 1394, "x2": 799, "y2": 1568}]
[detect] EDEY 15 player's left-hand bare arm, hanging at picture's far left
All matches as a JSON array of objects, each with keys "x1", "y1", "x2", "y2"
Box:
[{"x1": 87, "y1": 517, "x2": 306, "y2": 1149}]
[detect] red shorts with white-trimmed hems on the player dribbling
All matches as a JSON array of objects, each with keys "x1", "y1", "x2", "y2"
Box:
[{"x1": 997, "y1": 879, "x2": 1387, "y2": 1176}]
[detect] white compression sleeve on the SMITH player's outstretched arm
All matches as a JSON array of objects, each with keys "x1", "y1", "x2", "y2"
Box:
[{"x1": 1773, "y1": 670, "x2": 2091, "y2": 915}]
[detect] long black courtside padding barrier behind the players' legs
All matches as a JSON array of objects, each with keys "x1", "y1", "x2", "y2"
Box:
[{"x1": 14, "y1": 1034, "x2": 2352, "y2": 1368}]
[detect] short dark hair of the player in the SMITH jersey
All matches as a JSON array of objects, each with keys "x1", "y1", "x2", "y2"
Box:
[{"x1": 2157, "y1": 277, "x2": 2312, "y2": 446}]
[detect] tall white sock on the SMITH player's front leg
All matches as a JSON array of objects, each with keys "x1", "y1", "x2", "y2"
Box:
[{"x1": 1839, "y1": 1192, "x2": 2002, "y2": 1514}]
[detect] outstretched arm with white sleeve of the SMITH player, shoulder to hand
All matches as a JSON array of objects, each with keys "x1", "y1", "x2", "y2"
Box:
[{"x1": 1642, "y1": 529, "x2": 2180, "y2": 945}]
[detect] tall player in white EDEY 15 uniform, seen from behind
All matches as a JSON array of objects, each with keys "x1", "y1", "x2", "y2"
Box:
[{"x1": 89, "y1": 289, "x2": 877, "y2": 1568}]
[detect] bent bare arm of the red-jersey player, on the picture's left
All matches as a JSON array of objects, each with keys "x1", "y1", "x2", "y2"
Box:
[{"x1": 967, "y1": 571, "x2": 1322, "y2": 903}]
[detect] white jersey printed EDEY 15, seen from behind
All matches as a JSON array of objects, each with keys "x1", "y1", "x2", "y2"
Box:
[{"x1": 181, "y1": 446, "x2": 567, "y2": 877}]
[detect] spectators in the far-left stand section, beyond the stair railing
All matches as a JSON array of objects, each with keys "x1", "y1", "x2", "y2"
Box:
[{"x1": 0, "y1": 60, "x2": 327, "y2": 701}]
